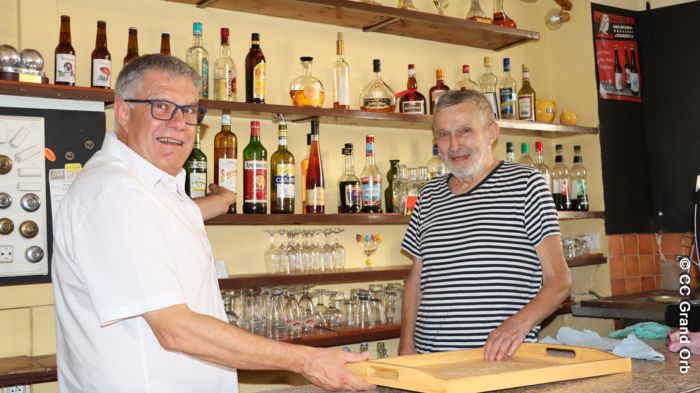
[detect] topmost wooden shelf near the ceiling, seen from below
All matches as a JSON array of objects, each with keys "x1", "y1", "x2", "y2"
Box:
[{"x1": 169, "y1": 0, "x2": 540, "y2": 50}]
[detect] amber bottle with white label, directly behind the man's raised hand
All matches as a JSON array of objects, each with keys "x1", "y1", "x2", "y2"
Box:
[{"x1": 214, "y1": 115, "x2": 238, "y2": 214}]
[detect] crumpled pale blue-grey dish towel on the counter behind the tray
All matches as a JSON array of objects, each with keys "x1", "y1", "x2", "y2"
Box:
[{"x1": 540, "y1": 326, "x2": 666, "y2": 362}]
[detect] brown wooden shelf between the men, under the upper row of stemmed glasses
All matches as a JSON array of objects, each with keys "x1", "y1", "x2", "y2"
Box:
[{"x1": 219, "y1": 265, "x2": 411, "y2": 289}]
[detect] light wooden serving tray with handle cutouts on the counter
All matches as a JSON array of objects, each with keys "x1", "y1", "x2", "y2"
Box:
[{"x1": 349, "y1": 343, "x2": 632, "y2": 393}]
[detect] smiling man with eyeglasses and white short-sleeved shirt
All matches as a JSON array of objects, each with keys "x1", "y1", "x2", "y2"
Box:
[{"x1": 52, "y1": 55, "x2": 371, "y2": 393}]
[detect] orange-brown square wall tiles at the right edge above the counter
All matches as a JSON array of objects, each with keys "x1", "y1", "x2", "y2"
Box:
[{"x1": 608, "y1": 233, "x2": 700, "y2": 296}]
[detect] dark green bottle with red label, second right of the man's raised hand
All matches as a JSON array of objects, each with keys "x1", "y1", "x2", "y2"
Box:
[{"x1": 243, "y1": 121, "x2": 267, "y2": 214}]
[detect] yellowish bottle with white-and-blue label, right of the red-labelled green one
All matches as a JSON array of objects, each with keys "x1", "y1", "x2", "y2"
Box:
[{"x1": 270, "y1": 123, "x2": 295, "y2": 214}]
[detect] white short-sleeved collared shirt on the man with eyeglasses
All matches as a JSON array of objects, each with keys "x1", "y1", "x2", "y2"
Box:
[{"x1": 53, "y1": 133, "x2": 238, "y2": 393}]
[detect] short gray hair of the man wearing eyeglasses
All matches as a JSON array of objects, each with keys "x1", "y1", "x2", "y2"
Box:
[{"x1": 114, "y1": 54, "x2": 201, "y2": 100}]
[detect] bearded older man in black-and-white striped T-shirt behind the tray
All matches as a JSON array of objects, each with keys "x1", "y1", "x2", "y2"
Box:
[{"x1": 399, "y1": 90, "x2": 571, "y2": 360}]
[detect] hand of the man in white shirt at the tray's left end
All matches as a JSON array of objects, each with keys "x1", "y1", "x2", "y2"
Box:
[{"x1": 302, "y1": 348, "x2": 374, "y2": 390}]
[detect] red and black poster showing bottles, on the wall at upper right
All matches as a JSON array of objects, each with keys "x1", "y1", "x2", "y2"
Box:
[{"x1": 593, "y1": 11, "x2": 642, "y2": 102}]
